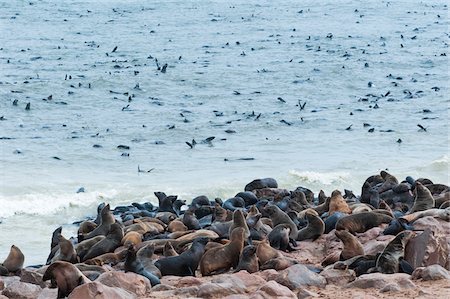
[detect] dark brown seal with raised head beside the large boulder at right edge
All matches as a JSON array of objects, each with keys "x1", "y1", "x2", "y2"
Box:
[{"x1": 376, "y1": 230, "x2": 415, "y2": 274}]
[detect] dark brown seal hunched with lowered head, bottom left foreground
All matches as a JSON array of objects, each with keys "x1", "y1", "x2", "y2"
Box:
[{"x1": 42, "y1": 261, "x2": 90, "y2": 298}]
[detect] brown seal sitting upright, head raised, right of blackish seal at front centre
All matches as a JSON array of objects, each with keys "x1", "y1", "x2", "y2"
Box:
[{"x1": 200, "y1": 227, "x2": 245, "y2": 276}]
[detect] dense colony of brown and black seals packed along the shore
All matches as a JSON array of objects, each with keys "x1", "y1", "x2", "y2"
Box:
[{"x1": 0, "y1": 171, "x2": 450, "y2": 298}]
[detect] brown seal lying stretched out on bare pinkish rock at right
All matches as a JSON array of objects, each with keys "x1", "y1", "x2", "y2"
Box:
[{"x1": 336, "y1": 212, "x2": 393, "y2": 234}]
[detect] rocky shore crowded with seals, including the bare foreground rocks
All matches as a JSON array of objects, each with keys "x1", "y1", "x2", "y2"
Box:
[{"x1": 0, "y1": 171, "x2": 450, "y2": 299}]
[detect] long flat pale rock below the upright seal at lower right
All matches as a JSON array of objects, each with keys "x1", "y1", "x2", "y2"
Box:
[{"x1": 346, "y1": 273, "x2": 416, "y2": 290}]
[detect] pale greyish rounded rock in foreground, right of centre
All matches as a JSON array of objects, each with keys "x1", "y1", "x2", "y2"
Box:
[{"x1": 275, "y1": 264, "x2": 326, "y2": 290}]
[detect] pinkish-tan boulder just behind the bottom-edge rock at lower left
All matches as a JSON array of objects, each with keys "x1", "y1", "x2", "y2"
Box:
[{"x1": 96, "y1": 271, "x2": 152, "y2": 296}]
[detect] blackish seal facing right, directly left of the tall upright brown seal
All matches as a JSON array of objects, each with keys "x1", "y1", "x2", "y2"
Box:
[{"x1": 155, "y1": 237, "x2": 208, "y2": 276}]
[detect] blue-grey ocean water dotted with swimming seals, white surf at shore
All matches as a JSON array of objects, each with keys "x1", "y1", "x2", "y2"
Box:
[{"x1": 0, "y1": 0, "x2": 450, "y2": 265}]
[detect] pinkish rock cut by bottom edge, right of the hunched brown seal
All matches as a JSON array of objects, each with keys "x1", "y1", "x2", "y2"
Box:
[{"x1": 68, "y1": 281, "x2": 137, "y2": 299}]
